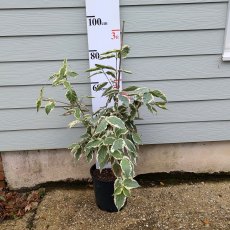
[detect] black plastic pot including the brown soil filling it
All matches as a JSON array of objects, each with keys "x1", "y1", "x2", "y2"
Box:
[{"x1": 90, "y1": 165, "x2": 118, "y2": 212}]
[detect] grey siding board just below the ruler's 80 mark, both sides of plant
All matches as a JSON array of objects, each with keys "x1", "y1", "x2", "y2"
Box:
[{"x1": 0, "y1": 55, "x2": 230, "y2": 86}]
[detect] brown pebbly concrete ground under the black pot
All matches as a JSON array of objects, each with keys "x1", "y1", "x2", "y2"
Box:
[{"x1": 0, "y1": 181, "x2": 230, "y2": 230}]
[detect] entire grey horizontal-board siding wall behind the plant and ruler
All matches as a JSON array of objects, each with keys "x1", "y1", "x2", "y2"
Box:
[{"x1": 0, "y1": 0, "x2": 230, "y2": 151}]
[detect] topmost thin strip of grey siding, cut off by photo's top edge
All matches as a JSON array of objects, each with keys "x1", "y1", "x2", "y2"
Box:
[{"x1": 0, "y1": 0, "x2": 228, "y2": 9}]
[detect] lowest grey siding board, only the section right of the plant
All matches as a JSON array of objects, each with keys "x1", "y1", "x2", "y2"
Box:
[{"x1": 139, "y1": 121, "x2": 230, "y2": 144}]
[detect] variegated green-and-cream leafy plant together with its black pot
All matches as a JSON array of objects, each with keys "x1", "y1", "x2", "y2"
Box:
[{"x1": 37, "y1": 45, "x2": 167, "y2": 211}]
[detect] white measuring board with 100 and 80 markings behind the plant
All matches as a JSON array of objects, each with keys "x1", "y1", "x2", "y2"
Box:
[{"x1": 86, "y1": 0, "x2": 121, "y2": 112}]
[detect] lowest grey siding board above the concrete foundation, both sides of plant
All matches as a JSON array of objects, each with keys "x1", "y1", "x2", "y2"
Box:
[{"x1": 0, "y1": 121, "x2": 230, "y2": 151}]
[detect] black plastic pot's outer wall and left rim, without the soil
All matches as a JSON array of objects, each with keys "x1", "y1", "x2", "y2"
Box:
[{"x1": 90, "y1": 165, "x2": 118, "y2": 212}]
